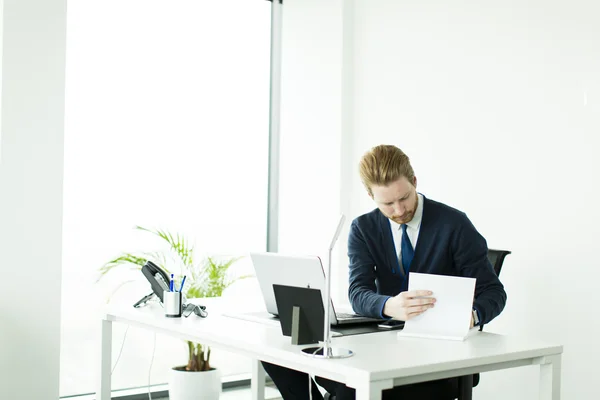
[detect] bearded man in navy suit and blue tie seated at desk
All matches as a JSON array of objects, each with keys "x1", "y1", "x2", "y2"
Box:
[{"x1": 263, "y1": 145, "x2": 506, "y2": 400}]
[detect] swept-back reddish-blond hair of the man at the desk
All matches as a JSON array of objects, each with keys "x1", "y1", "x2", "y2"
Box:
[{"x1": 359, "y1": 144, "x2": 415, "y2": 195}]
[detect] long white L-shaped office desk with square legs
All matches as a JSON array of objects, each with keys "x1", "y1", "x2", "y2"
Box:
[{"x1": 96, "y1": 303, "x2": 562, "y2": 400}]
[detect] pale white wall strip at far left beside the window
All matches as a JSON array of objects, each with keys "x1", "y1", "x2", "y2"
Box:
[{"x1": 0, "y1": 0, "x2": 66, "y2": 400}]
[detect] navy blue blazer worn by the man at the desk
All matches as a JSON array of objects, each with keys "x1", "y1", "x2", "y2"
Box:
[{"x1": 348, "y1": 196, "x2": 506, "y2": 324}]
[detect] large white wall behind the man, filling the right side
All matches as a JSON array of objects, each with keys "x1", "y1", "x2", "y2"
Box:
[{"x1": 343, "y1": 0, "x2": 600, "y2": 400}]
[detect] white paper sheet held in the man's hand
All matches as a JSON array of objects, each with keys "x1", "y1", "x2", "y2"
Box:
[{"x1": 398, "y1": 272, "x2": 475, "y2": 340}]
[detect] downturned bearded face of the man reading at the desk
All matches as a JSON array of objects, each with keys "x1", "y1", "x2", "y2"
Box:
[{"x1": 371, "y1": 176, "x2": 418, "y2": 224}]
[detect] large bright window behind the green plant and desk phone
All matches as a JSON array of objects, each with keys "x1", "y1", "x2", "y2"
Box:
[{"x1": 60, "y1": 0, "x2": 270, "y2": 396}]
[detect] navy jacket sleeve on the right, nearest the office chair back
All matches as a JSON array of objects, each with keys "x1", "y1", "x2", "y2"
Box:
[{"x1": 452, "y1": 214, "x2": 506, "y2": 324}]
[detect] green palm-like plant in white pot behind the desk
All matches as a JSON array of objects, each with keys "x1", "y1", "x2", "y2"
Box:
[{"x1": 99, "y1": 226, "x2": 250, "y2": 400}]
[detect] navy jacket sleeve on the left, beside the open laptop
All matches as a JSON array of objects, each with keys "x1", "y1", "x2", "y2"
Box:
[{"x1": 348, "y1": 220, "x2": 389, "y2": 318}]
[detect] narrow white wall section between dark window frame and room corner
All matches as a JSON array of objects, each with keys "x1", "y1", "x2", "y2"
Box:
[{"x1": 279, "y1": 0, "x2": 345, "y2": 304}]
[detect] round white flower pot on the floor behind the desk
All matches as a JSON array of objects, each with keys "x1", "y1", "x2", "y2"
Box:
[{"x1": 169, "y1": 367, "x2": 221, "y2": 400}]
